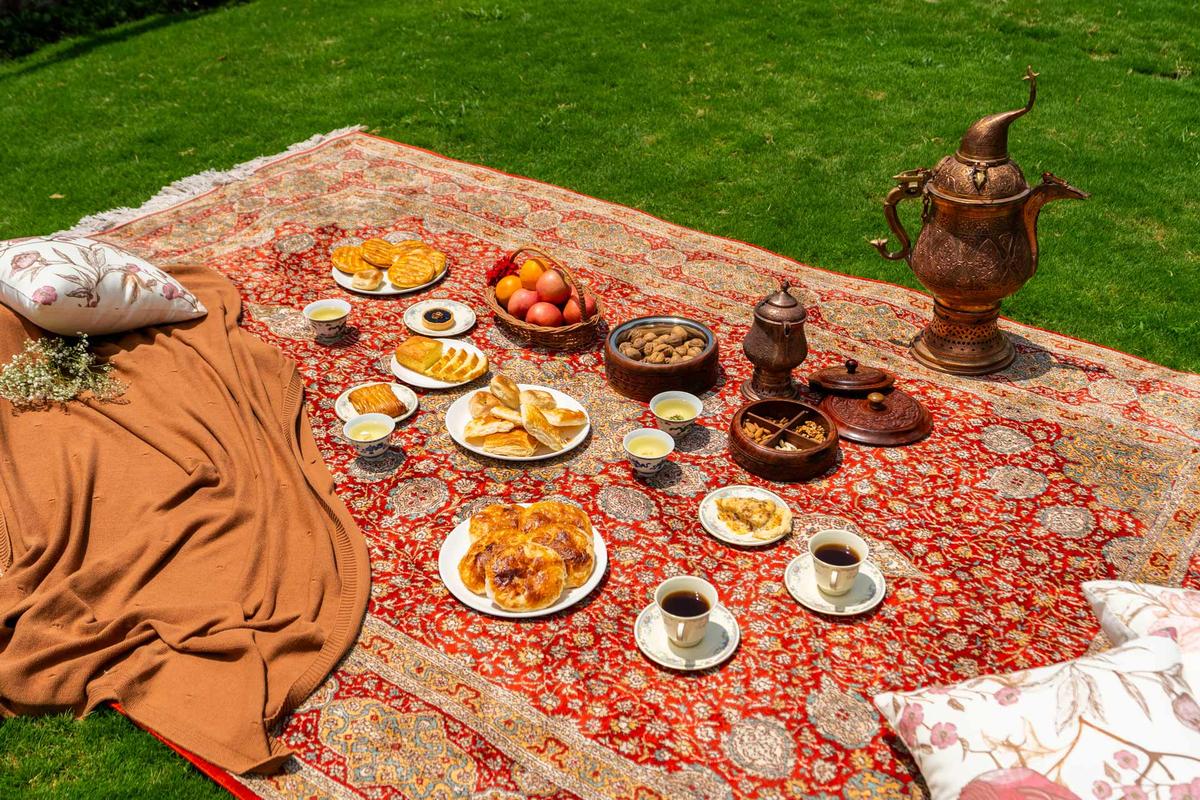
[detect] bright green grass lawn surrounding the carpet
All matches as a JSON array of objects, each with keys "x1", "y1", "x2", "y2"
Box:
[{"x1": 0, "y1": 0, "x2": 1200, "y2": 796}]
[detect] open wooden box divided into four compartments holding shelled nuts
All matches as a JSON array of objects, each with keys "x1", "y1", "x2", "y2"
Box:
[{"x1": 730, "y1": 399, "x2": 838, "y2": 482}]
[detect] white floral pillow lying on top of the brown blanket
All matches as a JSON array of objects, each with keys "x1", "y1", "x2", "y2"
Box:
[{"x1": 0, "y1": 235, "x2": 208, "y2": 336}]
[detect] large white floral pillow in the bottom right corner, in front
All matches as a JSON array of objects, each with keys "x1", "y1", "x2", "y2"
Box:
[{"x1": 875, "y1": 637, "x2": 1200, "y2": 800}]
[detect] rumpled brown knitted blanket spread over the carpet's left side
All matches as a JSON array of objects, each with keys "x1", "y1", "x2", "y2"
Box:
[{"x1": 0, "y1": 266, "x2": 370, "y2": 772}]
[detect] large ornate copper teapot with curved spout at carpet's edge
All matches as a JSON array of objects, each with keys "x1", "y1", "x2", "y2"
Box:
[{"x1": 871, "y1": 68, "x2": 1087, "y2": 375}]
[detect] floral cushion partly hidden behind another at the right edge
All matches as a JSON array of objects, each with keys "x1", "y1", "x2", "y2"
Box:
[{"x1": 1084, "y1": 581, "x2": 1200, "y2": 685}]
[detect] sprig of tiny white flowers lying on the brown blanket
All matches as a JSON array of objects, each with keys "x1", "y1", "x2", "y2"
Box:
[{"x1": 0, "y1": 336, "x2": 125, "y2": 410}]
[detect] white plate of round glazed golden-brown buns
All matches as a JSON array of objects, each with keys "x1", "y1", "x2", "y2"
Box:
[{"x1": 438, "y1": 500, "x2": 608, "y2": 618}]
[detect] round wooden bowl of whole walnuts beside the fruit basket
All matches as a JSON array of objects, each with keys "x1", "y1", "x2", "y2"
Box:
[{"x1": 604, "y1": 317, "x2": 719, "y2": 402}]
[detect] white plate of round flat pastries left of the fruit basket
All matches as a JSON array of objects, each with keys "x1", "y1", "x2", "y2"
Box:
[{"x1": 329, "y1": 239, "x2": 446, "y2": 296}]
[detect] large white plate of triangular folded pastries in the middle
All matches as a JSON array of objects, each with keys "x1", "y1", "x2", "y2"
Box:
[{"x1": 446, "y1": 374, "x2": 592, "y2": 461}]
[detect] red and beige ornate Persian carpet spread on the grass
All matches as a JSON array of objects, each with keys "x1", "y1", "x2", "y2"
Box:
[{"x1": 96, "y1": 133, "x2": 1200, "y2": 800}]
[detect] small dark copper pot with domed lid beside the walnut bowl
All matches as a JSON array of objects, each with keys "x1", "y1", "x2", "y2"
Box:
[{"x1": 742, "y1": 281, "x2": 809, "y2": 399}]
